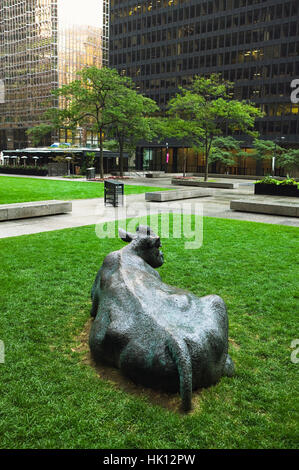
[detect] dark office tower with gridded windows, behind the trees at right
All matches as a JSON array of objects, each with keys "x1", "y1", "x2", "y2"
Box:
[{"x1": 110, "y1": 0, "x2": 299, "y2": 174}]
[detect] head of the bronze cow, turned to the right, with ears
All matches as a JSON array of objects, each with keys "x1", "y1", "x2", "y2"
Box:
[{"x1": 118, "y1": 225, "x2": 164, "y2": 268}]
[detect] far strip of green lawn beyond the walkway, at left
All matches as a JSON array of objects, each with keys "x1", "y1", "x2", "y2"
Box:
[{"x1": 0, "y1": 176, "x2": 165, "y2": 204}]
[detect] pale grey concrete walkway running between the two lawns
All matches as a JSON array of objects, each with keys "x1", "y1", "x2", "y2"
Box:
[{"x1": 0, "y1": 178, "x2": 299, "y2": 238}]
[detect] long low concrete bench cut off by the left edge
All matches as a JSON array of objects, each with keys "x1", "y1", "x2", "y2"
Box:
[{"x1": 0, "y1": 201, "x2": 72, "y2": 221}]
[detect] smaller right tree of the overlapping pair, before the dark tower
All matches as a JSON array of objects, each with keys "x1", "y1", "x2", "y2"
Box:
[{"x1": 107, "y1": 83, "x2": 158, "y2": 176}]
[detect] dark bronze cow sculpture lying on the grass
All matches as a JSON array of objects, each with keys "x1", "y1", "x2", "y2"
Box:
[{"x1": 89, "y1": 226, "x2": 234, "y2": 411}]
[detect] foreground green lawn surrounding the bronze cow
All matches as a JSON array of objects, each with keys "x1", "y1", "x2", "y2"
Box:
[{"x1": 0, "y1": 217, "x2": 299, "y2": 449}]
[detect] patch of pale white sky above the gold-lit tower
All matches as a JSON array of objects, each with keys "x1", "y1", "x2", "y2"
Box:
[{"x1": 58, "y1": 0, "x2": 103, "y2": 26}]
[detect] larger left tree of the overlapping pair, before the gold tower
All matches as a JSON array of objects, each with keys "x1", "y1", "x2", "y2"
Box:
[{"x1": 52, "y1": 67, "x2": 130, "y2": 178}]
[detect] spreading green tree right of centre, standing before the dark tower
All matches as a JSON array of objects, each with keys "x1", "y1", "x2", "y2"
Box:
[{"x1": 164, "y1": 74, "x2": 263, "y2": 181}]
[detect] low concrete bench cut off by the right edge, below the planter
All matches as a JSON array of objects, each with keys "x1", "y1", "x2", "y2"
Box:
[{"x1": 230, "y1": 200, "x2": 299, "y2": 217}]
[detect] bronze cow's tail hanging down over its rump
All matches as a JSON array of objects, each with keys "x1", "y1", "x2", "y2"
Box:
[{"x1": 167, "y1": 335, "x2": 192, "y2": 411}]
